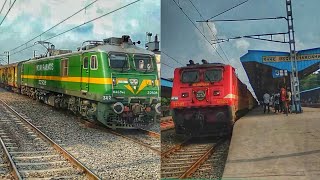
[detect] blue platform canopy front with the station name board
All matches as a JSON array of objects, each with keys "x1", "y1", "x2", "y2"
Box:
[{"x1": 240, "y1": 48, "x2": 320, "y2": 75}]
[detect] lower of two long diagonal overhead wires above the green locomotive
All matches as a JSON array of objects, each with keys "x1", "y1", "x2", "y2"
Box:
[{"x1": 11, "y1": 0, "x2": 141, "y2": 55}]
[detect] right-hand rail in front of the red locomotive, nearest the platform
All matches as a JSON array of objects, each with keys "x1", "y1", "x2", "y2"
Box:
[{"x1": 180, "y1": 138, "x2": 225, "y2": 178}]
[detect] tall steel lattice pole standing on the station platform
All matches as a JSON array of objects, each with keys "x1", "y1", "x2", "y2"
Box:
[{"x1": 286, "y1": 0, "x2": 302, "y2": 113}]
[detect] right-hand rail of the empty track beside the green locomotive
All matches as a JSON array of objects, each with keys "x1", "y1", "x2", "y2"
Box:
[{"x1": 0, "y1": 100, "x2": 100, "y2": 180}]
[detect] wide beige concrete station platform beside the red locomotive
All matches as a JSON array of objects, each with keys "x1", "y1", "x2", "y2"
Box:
[{"x1": 222, "y1": 107, "x2": 320, "y2": 180}]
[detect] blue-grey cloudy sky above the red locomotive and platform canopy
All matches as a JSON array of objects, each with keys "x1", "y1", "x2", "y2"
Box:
[{"x1": 161, "y1": 0, "x2": 320, "y2": 95}]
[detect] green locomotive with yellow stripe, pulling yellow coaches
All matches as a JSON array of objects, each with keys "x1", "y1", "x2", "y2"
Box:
[{"x1": 0, "y1": 36, "x2": 160, "y2": 129}]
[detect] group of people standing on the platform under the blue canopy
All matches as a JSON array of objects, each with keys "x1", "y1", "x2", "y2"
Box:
[{"x1": 263, "y1": 88, "x2": 292, "y2": 114}]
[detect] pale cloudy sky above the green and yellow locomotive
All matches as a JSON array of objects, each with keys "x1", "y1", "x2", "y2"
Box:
[{"x1": 0, "y1": 0, "x2": 160, "y2": 62}]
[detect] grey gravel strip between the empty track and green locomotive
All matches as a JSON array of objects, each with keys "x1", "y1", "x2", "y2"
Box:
[{"x1": 0, "y1": 89, "x2": 160, "y2": 179}]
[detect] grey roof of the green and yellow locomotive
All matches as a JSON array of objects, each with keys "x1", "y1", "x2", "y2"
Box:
[{"x1": 23, "y1": 43, "x2": 154, "y2": 62}]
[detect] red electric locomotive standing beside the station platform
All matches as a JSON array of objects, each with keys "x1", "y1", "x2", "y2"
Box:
[{"x1": 170, "y1": 60, "x2": 257, "y2": 135}]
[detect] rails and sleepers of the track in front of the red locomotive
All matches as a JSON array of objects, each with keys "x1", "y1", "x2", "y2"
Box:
[{"x1": 161, "y1": 137, "x2": 226, "y2": 178}]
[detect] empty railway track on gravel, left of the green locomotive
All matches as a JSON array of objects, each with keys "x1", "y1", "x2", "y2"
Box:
[{"x1": 0, "y1": 100, "x2": 100, "y2": 179}]
